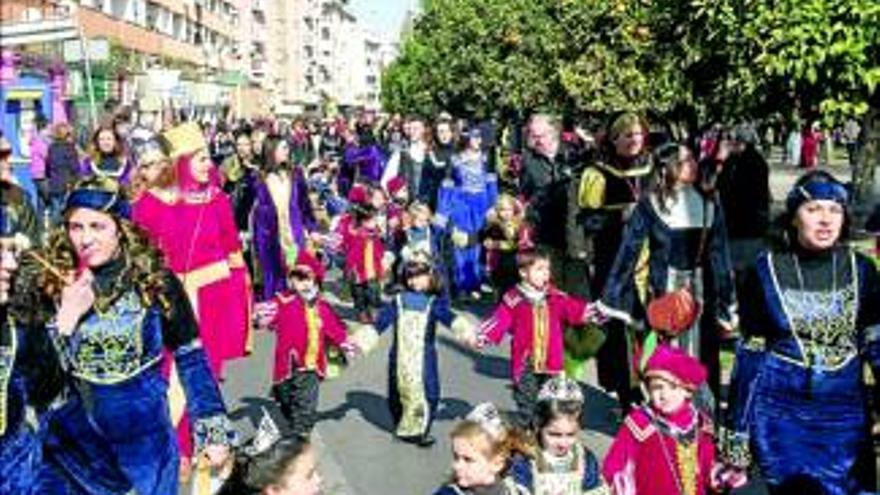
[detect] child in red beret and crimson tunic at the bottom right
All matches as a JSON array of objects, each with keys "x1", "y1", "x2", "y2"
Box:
[{"x1": 602, "y1": 345, "x2": 745, "y2": 495}]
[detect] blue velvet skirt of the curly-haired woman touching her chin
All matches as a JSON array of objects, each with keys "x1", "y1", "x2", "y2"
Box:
[{"x1": 41, "y1": 368, "x2": 180, "y2": 495}]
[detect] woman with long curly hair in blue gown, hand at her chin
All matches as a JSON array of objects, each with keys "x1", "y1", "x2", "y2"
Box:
[{"x1": 16, "y1": 178, "x2": 234, "y2": 495}]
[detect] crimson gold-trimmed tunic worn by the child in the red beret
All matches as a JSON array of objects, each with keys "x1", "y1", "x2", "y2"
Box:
[{"x1": 602, "y1": 404, "x2": 715, "y2": 495}]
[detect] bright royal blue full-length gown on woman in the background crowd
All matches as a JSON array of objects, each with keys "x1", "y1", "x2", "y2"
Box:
[{"x1": 437, "y1": 154, "x2": 498, "y2": 294}]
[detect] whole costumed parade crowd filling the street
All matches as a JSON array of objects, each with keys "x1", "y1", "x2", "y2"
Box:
[{"x1": 0, "y1": 101, "x2": 880, "y2": 495}]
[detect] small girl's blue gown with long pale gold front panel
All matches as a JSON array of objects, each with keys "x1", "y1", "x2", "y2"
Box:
[{"x1": 375, "y1": 291, "x2": 467, "y2": 438}]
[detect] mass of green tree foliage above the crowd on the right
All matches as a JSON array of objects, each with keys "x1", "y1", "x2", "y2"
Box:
[{"x1": 382, "y1": 0, "x2": 880, "y2": 126}]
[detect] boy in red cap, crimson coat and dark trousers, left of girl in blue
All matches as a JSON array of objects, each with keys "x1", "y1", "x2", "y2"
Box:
[{"x1": 257, "y1": 250, "x2": 357, "y2": 437}]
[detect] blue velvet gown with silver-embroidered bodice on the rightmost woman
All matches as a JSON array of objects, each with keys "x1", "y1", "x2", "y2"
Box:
[{"x1": 728, "y1": 248, "x2": 880, "y2": 495}]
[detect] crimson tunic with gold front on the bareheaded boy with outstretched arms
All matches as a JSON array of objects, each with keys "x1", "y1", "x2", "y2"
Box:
[{"x1": 480, "y1": 287, "x2": 591, "y2": 382}]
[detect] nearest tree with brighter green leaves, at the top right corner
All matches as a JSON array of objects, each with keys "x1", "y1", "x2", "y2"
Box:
[{"x1": 691, "y1": 0, "x2": 880, "y2": 197}]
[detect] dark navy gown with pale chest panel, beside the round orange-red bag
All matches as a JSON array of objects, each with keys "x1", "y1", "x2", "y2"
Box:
[{"x1": 602, "y1": 187, "x2": 738, "y2": 393}]
